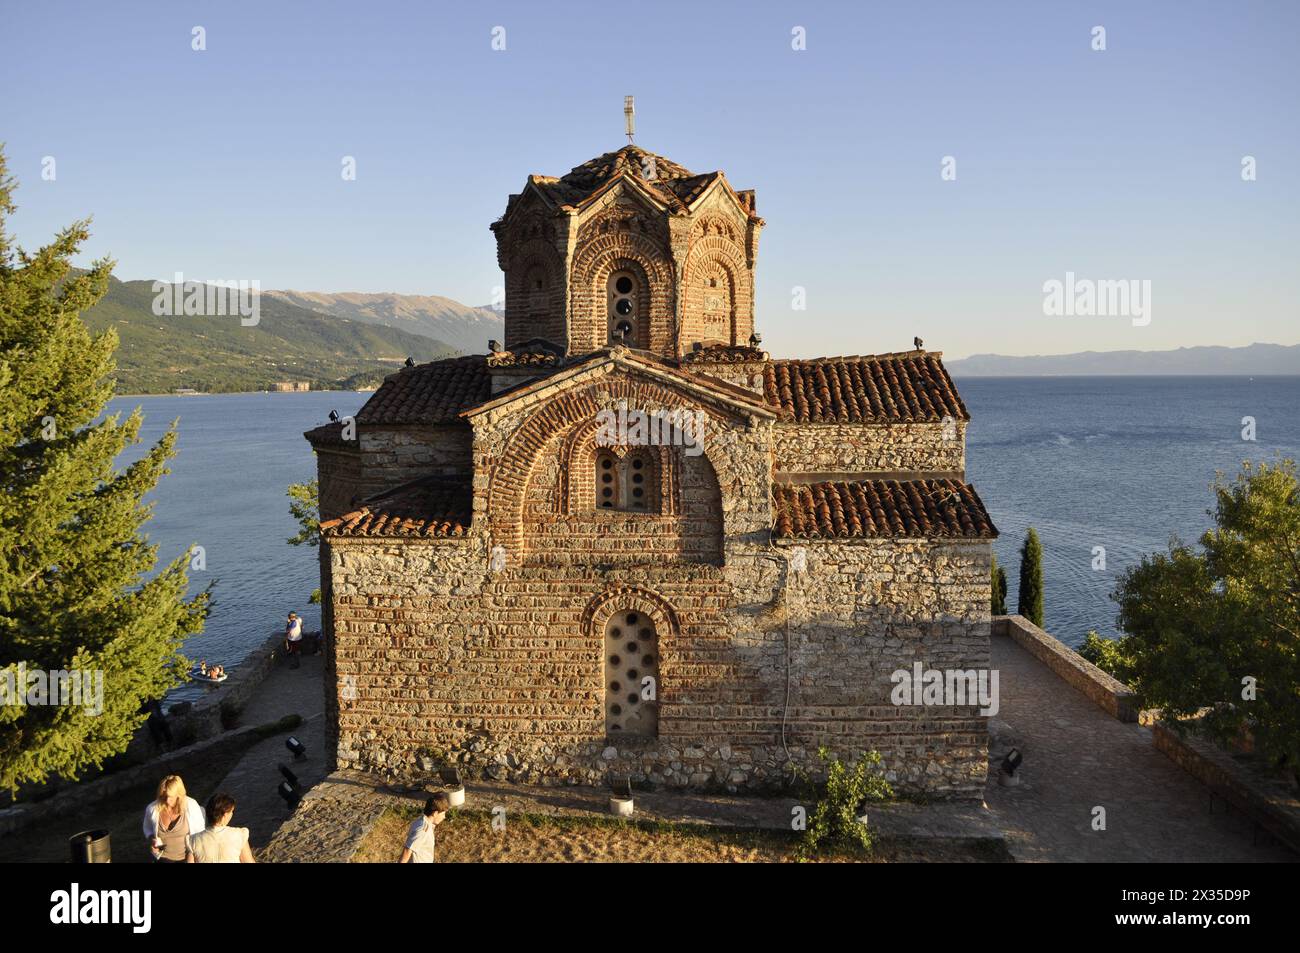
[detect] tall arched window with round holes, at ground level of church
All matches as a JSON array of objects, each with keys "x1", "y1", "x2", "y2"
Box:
[{"x1": 605, "y1": 611, "x2": 659, "y2": 738}]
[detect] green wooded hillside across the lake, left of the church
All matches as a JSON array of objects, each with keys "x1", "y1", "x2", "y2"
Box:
[{"x1": 83, "y1": 278, "x2": 454, "y2": 394}]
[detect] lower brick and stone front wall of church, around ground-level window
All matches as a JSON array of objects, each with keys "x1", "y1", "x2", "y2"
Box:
[{"x1": 322, "y1": 540, "x2": 988, "y2": 796}]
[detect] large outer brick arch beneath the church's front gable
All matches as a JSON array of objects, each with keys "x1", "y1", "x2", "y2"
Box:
[{"x1": 488, "y1": 374, "x2": 736, "y2": 555}]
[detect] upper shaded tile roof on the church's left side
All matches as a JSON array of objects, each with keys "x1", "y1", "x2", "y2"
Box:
[{"x1": 356, "y1": 354, "x2": 491, "y2": 424}]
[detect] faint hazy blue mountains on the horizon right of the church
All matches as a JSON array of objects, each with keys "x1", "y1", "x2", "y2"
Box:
[{"x1": 944, "y1": 345, "x2": 1300, "y2": 377}]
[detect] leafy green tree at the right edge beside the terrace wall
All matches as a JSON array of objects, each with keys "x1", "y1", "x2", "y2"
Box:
[{"x1": 1113, "y1": 460, "x2": 1300, "y2": 783}]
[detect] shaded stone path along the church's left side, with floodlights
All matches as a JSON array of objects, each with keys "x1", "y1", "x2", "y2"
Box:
[{"x1": 211, "y1": 655, "x2": 325, "y2": 849}]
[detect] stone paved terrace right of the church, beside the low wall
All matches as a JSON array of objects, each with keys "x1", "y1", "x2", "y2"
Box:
[{"x1": 984, "y1": 636, "x2": 1297, "y2": 862}]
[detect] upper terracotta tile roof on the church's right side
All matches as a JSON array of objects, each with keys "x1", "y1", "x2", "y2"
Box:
[{"x1": 763, "y1": 351, "x2": 970, "y2": 424}]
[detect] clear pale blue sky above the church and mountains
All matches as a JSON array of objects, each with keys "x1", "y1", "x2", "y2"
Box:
[{"x1": 0, "y1": 0, "x2": 1300, "y2": 358}]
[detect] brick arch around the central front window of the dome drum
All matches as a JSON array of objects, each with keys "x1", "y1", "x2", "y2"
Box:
[{"x1": 569, "y1": 222, "x2": 676, "y2": 354}]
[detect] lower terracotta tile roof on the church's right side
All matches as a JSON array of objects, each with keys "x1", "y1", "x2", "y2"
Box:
[{"x1": 772, "y1": 480, "x2": 997, "y2": 540}]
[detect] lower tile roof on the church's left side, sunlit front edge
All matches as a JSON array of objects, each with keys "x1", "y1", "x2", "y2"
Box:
[{"x1": 321, "y1": 477, "x2": 472, "y2": 538}]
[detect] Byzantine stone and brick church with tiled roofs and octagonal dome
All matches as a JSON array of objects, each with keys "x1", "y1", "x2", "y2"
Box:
[{"x1": 306, "y1": 146, "x2": 996, "y2": 797}]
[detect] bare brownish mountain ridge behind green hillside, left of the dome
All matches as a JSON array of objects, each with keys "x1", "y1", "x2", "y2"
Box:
[{"x1": 267, "y1": 291, "x2": 506, "y2": 354}]
